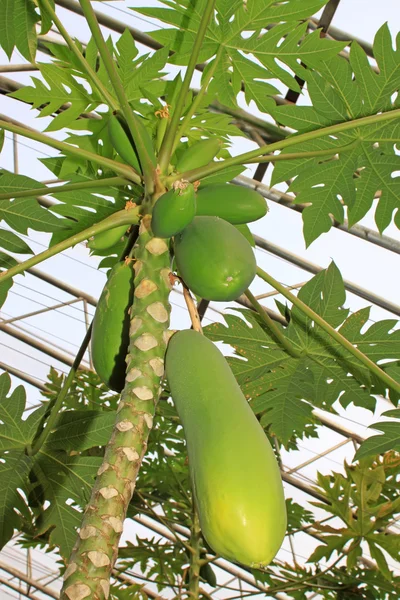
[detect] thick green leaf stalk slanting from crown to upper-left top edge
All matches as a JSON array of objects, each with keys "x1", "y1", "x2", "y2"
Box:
[{"x1": 79, "y1": 0, "x2": 158, "y2": 194}]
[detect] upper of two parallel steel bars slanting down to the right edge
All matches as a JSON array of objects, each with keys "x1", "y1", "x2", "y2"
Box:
[{"x1": 233, "y1": 175, "x2": 400, "y2": 254}]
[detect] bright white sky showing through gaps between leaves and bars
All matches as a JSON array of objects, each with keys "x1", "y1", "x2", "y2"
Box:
[{"x1": 0, "y1": 0, "x2": 400, "y2": 598}]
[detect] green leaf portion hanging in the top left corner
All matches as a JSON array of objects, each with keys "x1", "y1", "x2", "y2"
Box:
[{"x1": 0, "y1": 0, "x2": 39, "y2": 62}]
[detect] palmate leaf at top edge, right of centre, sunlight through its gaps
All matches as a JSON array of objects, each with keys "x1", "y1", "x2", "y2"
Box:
[{"x1": 134, "y1": 0, "x2": 346, "y2": 113}]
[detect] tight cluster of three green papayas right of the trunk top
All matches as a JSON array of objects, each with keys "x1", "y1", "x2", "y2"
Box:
[{"x1": 152, "y1": 180, "x2": 267, "y2": 302}]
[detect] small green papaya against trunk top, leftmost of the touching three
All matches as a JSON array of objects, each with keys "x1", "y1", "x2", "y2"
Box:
[{"x1": 151, "y1": 180, "x2": 196, "y2": 238}]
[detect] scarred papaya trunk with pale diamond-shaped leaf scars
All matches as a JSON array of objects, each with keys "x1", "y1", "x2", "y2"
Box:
[{"x1": 60, "y1": 215, "x2": 171, "y2": 600}]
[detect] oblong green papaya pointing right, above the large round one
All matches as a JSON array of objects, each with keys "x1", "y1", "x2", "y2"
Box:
[{"x1": 196, "y1": 183, "x2": 268, "y2": 225}]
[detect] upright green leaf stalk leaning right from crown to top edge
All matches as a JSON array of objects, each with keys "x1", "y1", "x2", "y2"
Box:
[{"x1": 159, "y1": 0, "x2": 215, "y2": 173}]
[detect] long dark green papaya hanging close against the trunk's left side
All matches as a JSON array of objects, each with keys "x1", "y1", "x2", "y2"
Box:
[{"x1": 92, "y1": 262, "x2": 135, "y2": 392}]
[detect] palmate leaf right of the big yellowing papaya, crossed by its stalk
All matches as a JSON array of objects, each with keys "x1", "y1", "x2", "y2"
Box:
[{"x1": 204, "y1": 263, "x2": 400, "y2": 445}]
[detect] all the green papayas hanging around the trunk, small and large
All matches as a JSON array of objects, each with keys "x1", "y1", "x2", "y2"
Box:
[{"x1": 91, "y1": 112, "x2": 286, "y2": 568}]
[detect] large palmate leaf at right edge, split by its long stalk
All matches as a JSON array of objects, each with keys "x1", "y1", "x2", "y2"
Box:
[{"x1": 271, "y1": 25, "x2": 400, "y2": 244}]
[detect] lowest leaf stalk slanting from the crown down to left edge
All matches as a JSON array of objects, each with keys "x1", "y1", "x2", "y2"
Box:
[{"x1": 0, "y1": 206, "x2": 139, "y2": 282}]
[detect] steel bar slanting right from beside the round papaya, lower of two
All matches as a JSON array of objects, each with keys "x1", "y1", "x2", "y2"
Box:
[{"x1": 254, "y1": 235, "x2": 400, "y2": 317}]
